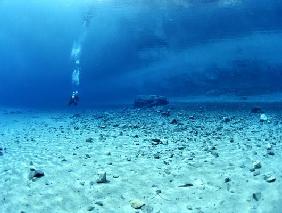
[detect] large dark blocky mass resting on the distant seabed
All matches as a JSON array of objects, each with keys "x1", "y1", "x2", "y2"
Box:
[{"x1": 134, "y1": 95, "x2": 169, "y2": 108}]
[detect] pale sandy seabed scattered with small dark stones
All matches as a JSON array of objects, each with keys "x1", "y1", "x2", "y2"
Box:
[{"x1": 0, "y1": 103, "x2": 282, "y2": 213}]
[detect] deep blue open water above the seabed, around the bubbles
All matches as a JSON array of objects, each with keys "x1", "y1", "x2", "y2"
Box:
[{"x1": 0, "y1": 0, "x2": 282, "y2": 106}]
